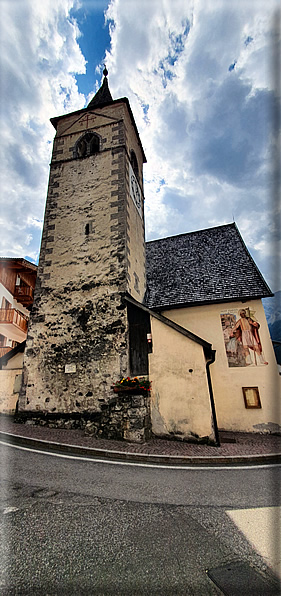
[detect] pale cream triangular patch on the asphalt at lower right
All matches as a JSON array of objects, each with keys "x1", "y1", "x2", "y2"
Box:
[{"x1": 226, "y1": 507, "x2": 281, "y2": 576}]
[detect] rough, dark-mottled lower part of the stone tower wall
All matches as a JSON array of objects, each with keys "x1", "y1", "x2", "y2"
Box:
[{"x1": 18, "y1": 290, "x2": 129, "y2": 414}]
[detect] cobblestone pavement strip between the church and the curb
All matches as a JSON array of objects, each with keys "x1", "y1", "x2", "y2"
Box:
[{"x1": 0, "y1": 415, "x2": 281, "y2": 458}]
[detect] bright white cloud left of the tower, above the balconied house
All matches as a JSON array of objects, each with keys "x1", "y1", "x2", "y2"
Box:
[{"x1": 0, "y1": 0, "x2": 85, "y2": 259}]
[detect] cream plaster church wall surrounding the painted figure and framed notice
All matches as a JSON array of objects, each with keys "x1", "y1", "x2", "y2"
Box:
[{"x1": 163, "y1": 300, "x2": 280, "y2": 432}]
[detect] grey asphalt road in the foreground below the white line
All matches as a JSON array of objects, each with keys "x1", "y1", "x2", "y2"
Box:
[{"x1": 0, "y1": 446, "x2": 280, "y2": 596}]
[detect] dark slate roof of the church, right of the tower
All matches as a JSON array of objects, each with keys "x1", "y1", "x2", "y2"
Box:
[{"x1": 145, "y1": 223, "x2": 273, "y2": 310}]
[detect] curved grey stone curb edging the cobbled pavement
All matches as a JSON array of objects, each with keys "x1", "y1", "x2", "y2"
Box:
[{"x1": 0, "y1": 431, "x2": 281, "y2": 467}]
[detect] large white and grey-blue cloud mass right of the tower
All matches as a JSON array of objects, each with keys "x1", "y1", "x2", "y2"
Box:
[{"x1": 106, "y1": 0, "x2": 280, "y2": 289}]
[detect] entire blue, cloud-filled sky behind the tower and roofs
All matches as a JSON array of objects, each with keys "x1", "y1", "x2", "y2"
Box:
[{"x1": 0, "y1": 0, "x2": 280, "y2": 292}]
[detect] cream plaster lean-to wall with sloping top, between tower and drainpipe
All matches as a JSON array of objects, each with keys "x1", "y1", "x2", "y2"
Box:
[{"x1": 149, "y1": 317, "x2": 214, "y2": 440}]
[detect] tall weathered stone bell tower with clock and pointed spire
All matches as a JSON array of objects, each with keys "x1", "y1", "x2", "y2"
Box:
[{"x1": 19, "y1": 70, "x2": 146, "y2": 414}]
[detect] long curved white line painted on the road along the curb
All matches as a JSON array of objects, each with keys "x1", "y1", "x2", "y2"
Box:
[{"x1": 0, "y1": 441, "x2": 280, "y2": 471}]
